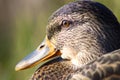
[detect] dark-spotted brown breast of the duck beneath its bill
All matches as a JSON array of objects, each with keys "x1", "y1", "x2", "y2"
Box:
[{"x1": 32, "y1": 58, "x2": 74, "y2": 80}]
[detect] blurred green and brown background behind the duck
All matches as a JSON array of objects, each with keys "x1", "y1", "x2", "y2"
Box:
[{"x1": 0, "y1": 0, "x2": 120, "y2": 80}]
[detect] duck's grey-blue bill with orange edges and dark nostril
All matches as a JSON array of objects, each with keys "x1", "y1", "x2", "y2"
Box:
[{"x1": 15, "y1": 38, "x2": 61, "y2": 71}]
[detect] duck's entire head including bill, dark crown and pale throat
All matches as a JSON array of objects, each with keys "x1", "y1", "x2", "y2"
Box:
[{"x1": 16, "y1": 1, "x2": 120, "y2": 70}]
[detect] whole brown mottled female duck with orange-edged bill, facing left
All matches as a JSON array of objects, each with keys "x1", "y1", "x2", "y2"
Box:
[{"x1": 15, "y1": 1, "x2": 120, "y2": 80}]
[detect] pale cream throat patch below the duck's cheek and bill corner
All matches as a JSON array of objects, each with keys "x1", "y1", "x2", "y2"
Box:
[{"x1": 61, "y1": 47, "x2": 103, "y2": 69}]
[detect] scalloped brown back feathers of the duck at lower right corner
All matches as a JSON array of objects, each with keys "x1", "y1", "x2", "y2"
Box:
[{"x1": 66, "y1": 49, "x2": 120, "y2": 80}]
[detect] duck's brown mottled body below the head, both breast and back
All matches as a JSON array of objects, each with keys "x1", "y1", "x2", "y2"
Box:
[{"x1": 31, "y1": 49, "x2": 120, "y2": 80}]
